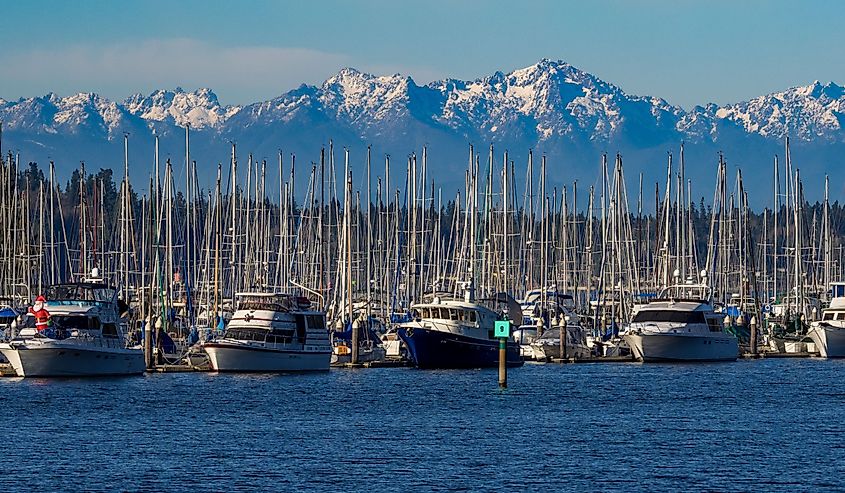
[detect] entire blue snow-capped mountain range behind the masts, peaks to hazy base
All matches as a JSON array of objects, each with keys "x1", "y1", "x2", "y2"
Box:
[{"x1": 0, "y1": 59, "x2": 845, "y2": 202}]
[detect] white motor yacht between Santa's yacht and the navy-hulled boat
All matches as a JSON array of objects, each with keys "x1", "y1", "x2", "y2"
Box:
[{"x1": 202, "y1": 293, "x2": 332, "y2": 372}]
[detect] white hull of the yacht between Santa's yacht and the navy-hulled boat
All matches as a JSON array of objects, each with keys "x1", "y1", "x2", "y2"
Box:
[{"x1": 203, "y1": 343, "x2": 331, "y2": 373}]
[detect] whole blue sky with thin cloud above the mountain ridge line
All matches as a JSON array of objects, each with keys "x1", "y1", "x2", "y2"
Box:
[{"x1": 0, "y1": 0, "x2": 845, "y2": 109}]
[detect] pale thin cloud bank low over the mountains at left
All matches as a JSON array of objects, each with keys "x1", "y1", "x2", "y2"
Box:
[{"x1": 0, "y1": 39, "x2": 352, "y2": 104}]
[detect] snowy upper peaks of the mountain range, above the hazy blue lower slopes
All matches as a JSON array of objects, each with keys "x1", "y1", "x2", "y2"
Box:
[{"x1": 0, "y1": 59, "x2": 845, "y2": 147}]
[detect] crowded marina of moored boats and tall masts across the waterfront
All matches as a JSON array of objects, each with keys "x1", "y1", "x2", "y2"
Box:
[{"x1": 0, "y1": 132, "x2": 845, "y2": 376}]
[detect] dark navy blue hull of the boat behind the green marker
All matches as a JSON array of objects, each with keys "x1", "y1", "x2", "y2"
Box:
[{"x1": 398, "y1": 327, "x2": 523, "y2": 369}]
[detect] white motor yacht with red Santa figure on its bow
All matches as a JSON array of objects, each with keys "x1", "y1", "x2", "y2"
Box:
[{"x1": 0, "y1": 282, "x2": 144, "y2": 377}]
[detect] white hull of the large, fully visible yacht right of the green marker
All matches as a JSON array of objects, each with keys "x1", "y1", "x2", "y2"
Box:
[{"x1": 623, "y1": 334, "x2": 739, "y2": 361}]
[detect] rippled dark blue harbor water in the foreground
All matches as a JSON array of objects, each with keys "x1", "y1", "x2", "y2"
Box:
[{"x1": 0, "y1": 359, "x2": 845, "y2": 492}]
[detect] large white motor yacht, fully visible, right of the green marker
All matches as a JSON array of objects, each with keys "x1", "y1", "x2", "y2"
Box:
[{"x1": 623, "y1": 282, "x2": 739, "y2": 361}]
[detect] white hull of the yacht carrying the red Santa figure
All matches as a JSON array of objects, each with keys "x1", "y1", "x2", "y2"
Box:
[{"x1": 0, "y1": 344, "x2": 145, "y2": 377}]
